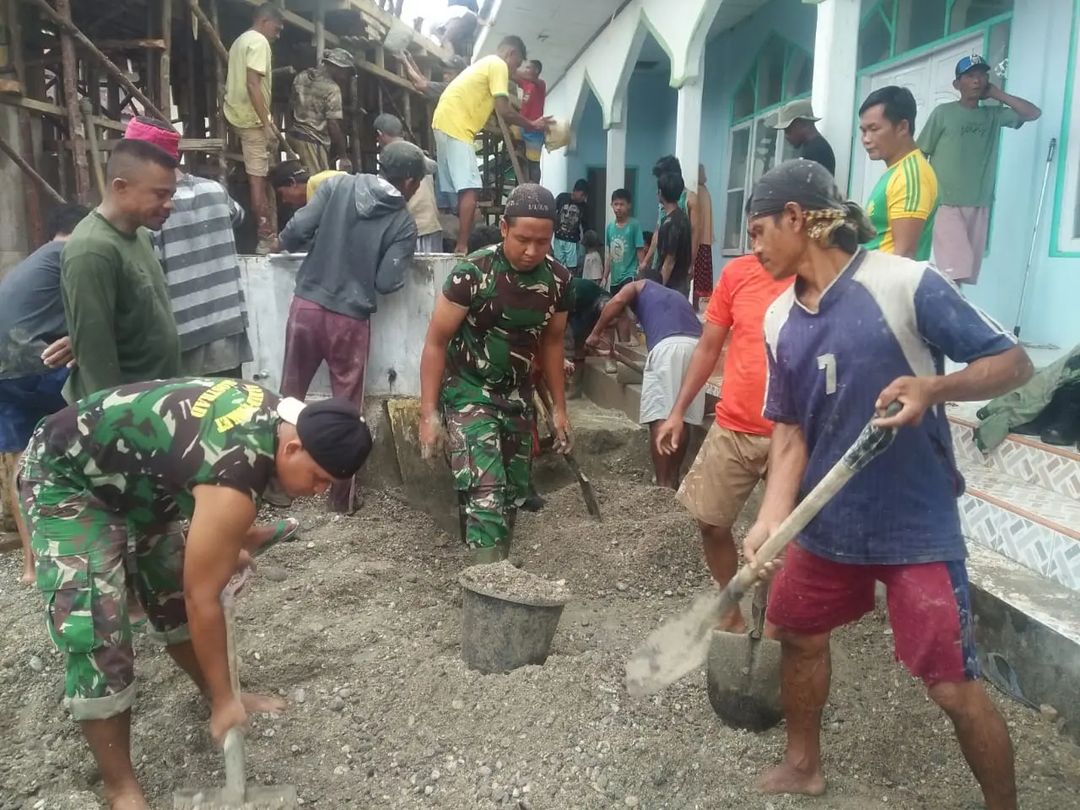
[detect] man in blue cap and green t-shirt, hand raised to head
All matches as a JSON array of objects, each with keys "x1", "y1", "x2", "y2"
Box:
[{"x1": 917, "y1": 54, "x2": 1042, "y2": 284}]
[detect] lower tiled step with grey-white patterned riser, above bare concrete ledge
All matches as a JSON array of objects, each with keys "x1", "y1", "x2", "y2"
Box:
[{"x1": 960, "y1": 465, "x2": 1080, "y2": 591}]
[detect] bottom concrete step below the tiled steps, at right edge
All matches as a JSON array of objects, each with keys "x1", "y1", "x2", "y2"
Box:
[{"x1": 968, "y1": 543, "x2": 1080, "y2": 742}]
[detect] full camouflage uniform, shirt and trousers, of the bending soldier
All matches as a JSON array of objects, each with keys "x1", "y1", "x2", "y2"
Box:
[{"x1": 18, "y1": 379, "x2": 280, "y2": 719}]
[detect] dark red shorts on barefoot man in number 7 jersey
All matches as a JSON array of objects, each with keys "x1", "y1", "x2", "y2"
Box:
[{"x1": 768, "y1": 545, "x2": 978, "y2": 686}]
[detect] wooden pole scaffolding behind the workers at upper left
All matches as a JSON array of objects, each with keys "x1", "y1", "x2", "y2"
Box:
[{"x1": 0, "y1": 0, "x2": 451, "y2": 248}]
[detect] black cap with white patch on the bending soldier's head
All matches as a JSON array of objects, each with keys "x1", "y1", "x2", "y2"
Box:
[{"x1": 278, "y1": 396, "x2": 372, "y2": 481}]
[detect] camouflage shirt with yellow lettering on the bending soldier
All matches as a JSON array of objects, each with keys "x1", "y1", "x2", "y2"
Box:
[{"x1": 23, "y1": 378, "x2": 281, "y2": 526}]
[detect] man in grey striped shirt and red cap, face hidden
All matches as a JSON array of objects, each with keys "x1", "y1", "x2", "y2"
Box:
[{"x1": 125, "y1": 118, "x2": 252, "y2": 378}]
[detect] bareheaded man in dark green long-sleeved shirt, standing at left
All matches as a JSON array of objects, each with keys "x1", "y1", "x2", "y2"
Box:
[{"x1": 60, "y1": 138, "x2": 180, "y2": 400}]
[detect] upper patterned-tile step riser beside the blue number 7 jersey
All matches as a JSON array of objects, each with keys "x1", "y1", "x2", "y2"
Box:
[{"x1": 950, "y1": 413, "x2": 1080, "y2": 500}]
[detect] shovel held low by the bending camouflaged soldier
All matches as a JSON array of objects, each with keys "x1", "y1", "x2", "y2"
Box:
[{"x1": 173, "y1": 579, "x2": 297, "y2": 810}]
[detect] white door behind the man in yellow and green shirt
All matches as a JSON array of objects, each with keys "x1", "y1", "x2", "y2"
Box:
[{"x1": 851, "y1": 36, "x2": 983, "y2": 203}]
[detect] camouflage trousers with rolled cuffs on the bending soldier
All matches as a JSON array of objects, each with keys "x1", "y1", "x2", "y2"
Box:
[{"x1": 18, "y1": 468, "x2": 190, "y2": 720}]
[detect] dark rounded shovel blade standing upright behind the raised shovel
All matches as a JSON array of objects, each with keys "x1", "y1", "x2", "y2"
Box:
[{"x1": 705, "y1": 631, "x2": 784, "y2": 731}]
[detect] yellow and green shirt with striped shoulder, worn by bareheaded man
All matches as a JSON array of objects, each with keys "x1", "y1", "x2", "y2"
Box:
[{"x1": 866, "y1": 149, "x2": 937, "y2": 261}]
